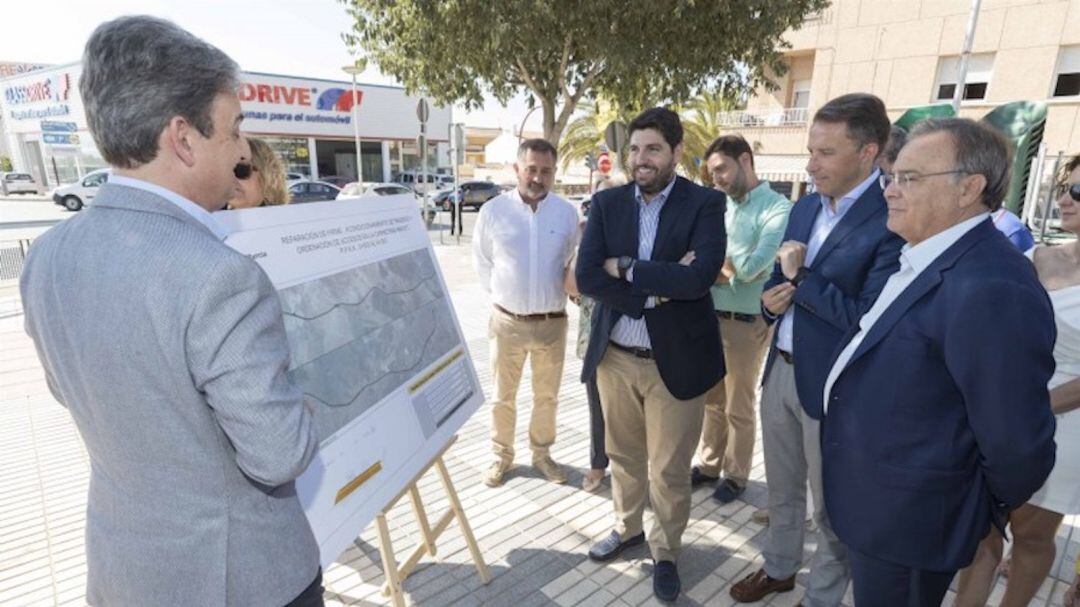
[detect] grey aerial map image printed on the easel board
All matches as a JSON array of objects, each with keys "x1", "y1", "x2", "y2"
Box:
[{"x1": 279, "y1": 248, "x2": 460, "y2": 441}]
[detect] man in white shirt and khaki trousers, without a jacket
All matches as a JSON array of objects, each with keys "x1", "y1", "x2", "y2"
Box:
[{"x1": 473, "y1": 139, "x2": 578, "y2": 487}]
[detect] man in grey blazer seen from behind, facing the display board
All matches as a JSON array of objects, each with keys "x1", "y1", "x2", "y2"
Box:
[{"x1": 21, "y1": 17, "x2": 323, "y2": 606}]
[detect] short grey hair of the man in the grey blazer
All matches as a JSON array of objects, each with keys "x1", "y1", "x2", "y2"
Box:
[{"x1": 79, "y1": 15, "x2": 240, "y2": 168}]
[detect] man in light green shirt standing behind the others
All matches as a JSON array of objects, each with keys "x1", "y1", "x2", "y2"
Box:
[{"x1": 691, "y1": 135, "x2": 792, "y2": 503}]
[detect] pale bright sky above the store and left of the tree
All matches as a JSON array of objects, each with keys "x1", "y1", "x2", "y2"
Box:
[{"x1": 0, "y1": 0, "x2": 541, "y2": 131}]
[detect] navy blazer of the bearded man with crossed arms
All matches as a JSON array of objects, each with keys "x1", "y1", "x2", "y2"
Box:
[{"x1": 577, "y1": 177, "x2": 727, "y2": 400}]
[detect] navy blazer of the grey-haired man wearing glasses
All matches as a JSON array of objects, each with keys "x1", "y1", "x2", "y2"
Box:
[{"x1": 822, "y1": 220, "x2": 1056, "y2": 571}]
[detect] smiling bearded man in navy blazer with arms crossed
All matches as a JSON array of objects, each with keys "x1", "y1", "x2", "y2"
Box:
[{"x1": 577, "y1": 108, "x2": 725, "y2": 601}]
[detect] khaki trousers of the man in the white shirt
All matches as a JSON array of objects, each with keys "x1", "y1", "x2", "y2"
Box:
[{"x1": 488, "y1": 310, "x2": 567, "y2": 462}]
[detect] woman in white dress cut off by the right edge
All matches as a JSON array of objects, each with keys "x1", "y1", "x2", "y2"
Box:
[{"x1": 954, "y1": 157, "x2": 1080, "y2": 607}]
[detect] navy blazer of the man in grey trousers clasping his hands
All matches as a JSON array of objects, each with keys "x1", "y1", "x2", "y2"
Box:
[{"x1": 762, "y1": 184, "x2": 904, "y2": 420}]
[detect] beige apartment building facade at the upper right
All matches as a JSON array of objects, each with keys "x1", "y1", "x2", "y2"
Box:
[{"x1": 721, "y1": 0, "x2": 1080, "y2": 198}]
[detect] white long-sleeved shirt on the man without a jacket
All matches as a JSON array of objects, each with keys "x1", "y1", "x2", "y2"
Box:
[{"x1": 473, "y1": 189, "x2": 579, "y2": 314}]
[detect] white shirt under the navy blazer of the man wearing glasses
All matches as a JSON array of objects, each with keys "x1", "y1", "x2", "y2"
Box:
[{"x1": 823, "y1": 213, "x2": 990, "y2": 414}]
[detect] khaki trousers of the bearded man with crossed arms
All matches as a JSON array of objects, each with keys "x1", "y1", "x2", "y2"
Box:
[{"x1": 596, "y1": 348, "x2": 705, "y2": 562}]
